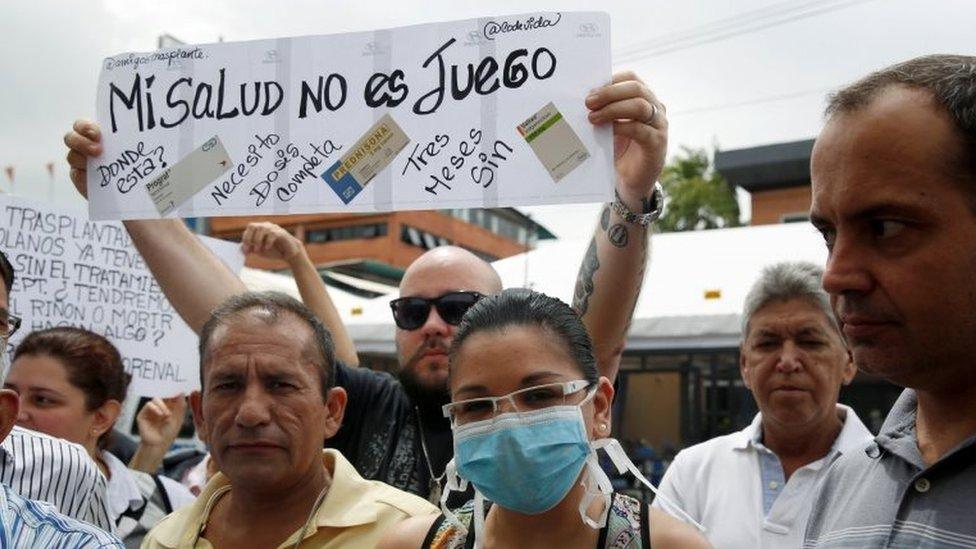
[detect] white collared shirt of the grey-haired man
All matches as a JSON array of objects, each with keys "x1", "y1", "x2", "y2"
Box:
[{"x1": 653, "y1": 404, "x2": 872, "y2": 548}]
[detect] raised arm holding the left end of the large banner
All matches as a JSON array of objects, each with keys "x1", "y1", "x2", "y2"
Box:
[{"x1": 64, "y1": 120, "x2": 247, "y2": 333}]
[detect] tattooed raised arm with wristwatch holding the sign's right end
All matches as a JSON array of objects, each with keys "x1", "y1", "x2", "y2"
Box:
[{"x1": 573, "y1": 72, "x2": 668, "y2": 381}]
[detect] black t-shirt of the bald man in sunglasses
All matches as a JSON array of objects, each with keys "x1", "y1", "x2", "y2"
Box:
[{"x1": 325, "y1": 363, "x2": 454, "y2": 498}]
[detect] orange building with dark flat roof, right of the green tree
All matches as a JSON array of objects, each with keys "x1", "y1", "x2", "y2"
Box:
[{"x1": 715, "y1": 139, "x2": 813, "y2": 225}]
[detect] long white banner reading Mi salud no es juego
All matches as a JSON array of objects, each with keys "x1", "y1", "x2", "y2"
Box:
[{"x1": 88, "y1": 12, "x2": 615, "y2": 219}]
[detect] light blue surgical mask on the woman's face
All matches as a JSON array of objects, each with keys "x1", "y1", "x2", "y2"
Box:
[{"x1": 454, "y1": 398, "x2": 590, "y2": 515}]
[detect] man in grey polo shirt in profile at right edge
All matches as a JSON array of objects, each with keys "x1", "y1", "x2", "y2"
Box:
[{"x1": 804, "y1": 55, "x2": 976, "y2": 548}]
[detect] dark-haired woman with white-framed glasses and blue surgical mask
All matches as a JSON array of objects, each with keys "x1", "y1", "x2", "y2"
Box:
[{"x1": 378, "y1": 288, "x2": 709, "y2": 549}]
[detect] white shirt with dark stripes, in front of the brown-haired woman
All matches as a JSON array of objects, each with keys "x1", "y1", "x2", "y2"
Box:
[{"x1": 0, "y1": 427, "x2": 114, "y2": 532}]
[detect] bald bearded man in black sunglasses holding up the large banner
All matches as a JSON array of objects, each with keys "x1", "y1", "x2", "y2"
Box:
[{"x1": 65, "y1": 72, "x2": 668, "y2": 500}]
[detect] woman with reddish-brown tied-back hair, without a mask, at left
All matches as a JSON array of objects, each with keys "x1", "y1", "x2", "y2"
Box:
[{"x1": 5, "y1": 327, "x2": 194, "y2": 547}]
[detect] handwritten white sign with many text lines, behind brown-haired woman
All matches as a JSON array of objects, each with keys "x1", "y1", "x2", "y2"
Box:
[{"x1": 0, "y1": 194, "x2": 244, "y2": 396}]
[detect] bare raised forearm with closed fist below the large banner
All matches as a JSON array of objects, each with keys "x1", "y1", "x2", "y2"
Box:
[{"x1": 241, "y1": 222, "x2": 359, "y2": 366}]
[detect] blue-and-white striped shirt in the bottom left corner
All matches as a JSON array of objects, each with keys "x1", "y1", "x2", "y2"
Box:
[{"x1": 0, "y1": 485, "x2": 125, "y2": 549}]
